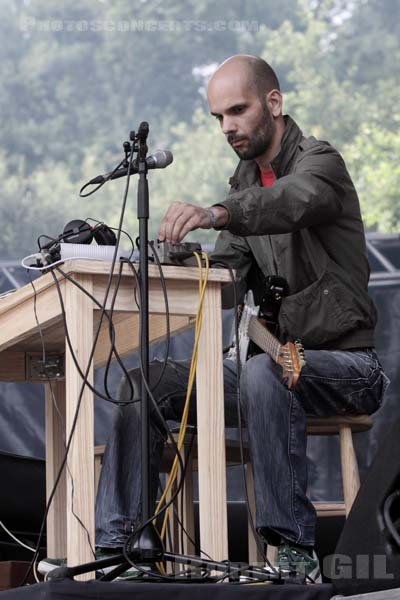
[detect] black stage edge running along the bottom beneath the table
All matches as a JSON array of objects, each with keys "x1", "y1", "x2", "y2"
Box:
[{"x1": 0, "y1": 579, "x2": 334, "y2": 600}]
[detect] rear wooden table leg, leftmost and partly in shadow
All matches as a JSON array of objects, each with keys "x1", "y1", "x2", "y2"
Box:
[{"x1": 45, "y1": 381, "x2": 67, "y2": 558}]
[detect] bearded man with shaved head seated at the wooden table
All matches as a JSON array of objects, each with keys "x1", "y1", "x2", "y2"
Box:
[{"x1": 54, "y1": 56, "x2": 387, "y2": 579}]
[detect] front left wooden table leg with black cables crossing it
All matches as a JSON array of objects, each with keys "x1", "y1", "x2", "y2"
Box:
[{"x1": 65, "y1": 275, "x2": 94, "y2": 579}]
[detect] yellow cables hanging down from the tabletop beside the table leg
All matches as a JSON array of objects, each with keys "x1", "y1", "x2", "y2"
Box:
[{"x1": 155, "y1": 252, "x2": 210, "y2": 538}]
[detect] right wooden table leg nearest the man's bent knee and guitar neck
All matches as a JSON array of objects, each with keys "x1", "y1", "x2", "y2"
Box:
[{"x1": 196, "y1": 282, "x2": 228, "y2": 560}]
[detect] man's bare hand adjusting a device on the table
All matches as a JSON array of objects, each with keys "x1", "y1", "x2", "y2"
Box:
[{"x1": 158, "y1": 202, "x2": 228, "y2": 244}]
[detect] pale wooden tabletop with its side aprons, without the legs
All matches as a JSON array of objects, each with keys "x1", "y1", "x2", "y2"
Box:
[{"x1": 0, "y1": 259, "x2": 231, "y2": 381}]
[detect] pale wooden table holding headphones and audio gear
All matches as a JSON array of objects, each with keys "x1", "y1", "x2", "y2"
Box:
[{"x1": 0, "y1": 260, "x2": 230, "y2": 578}]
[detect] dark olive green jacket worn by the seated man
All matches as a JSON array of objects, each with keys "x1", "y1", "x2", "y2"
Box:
[{"x1": 212, "y1": 116, "x2": 376, "y2": 349}]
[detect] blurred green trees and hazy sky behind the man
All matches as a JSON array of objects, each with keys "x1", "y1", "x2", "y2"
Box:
[{"x1": 0, "y1": 0, "x2": 400, "y2": 258}]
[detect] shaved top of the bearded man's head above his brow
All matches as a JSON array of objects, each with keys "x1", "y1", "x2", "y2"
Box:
[{"x1": 208, "y1": 54, "x2": 280, "y2": 99}]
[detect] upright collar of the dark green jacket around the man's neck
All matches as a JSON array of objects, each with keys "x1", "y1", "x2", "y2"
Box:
[{"x1": 229, "y1": 115, "x2": 303, "y2": 189}]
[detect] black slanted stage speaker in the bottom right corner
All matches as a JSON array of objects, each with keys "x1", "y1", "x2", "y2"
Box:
[{"x1": 323, "y1": 419, "x2": 400, "y2": 595}]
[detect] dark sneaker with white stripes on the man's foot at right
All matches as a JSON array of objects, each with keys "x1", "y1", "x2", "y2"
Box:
[{"x1": 276, "y1": 542, "x2": 322, "y2": 583}]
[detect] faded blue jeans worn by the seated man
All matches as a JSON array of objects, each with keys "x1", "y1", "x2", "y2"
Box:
[{"x1": 96, "y1": 350, "x2": 388, "y2": 548}]
